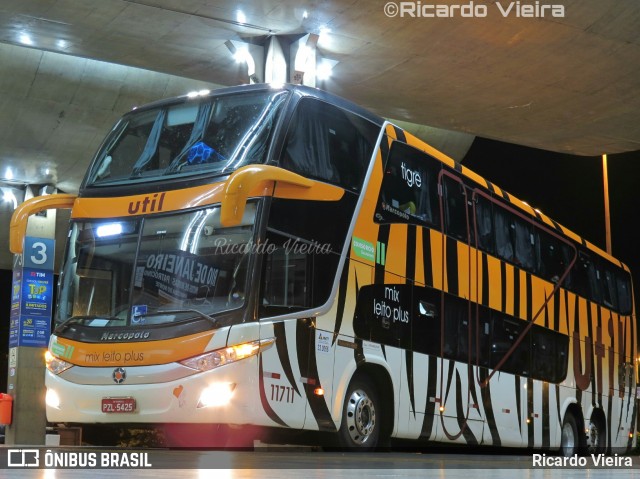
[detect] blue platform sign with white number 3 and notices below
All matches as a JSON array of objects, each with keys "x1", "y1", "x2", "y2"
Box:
[{"x1": 9, "y1": 236, "x2": 55, "y2": 348}]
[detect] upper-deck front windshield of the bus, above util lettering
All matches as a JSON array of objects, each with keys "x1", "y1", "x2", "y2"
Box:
[{"x1": 85, "y1": 90, "x2": 288, "y2": 187}]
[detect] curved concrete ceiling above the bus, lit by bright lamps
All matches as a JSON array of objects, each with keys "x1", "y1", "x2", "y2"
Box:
[{"x1": 0, "y1": 0, "x2": 640, "y2": 270}]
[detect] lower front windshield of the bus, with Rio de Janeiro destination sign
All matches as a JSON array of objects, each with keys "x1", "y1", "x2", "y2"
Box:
[{"x1": 57, "y1": 203, "x2": 256, "y2": 327}]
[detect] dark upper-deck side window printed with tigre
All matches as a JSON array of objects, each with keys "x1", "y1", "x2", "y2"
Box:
[{"x1": 375, "y1": 141, "x2": 440, "y2": 225}]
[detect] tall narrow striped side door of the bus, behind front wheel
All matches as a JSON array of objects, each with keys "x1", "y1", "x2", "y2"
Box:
[{"x1": 438, "y1": 170, "x2": 483, "y2": 444}]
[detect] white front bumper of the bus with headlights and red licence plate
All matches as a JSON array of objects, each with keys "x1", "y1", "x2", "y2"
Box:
[{"x1": 45, "y1": 358, "x2": 264, "y2": 424}]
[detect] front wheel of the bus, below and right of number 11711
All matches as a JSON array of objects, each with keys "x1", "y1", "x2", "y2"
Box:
[{"x1": 338, "y1": 376, "x2": 382, "y2": 451}]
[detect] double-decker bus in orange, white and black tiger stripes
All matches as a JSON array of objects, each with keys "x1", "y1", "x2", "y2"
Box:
[{"x1": 11, "y1": 85, "x2": 637, "y2": 454}]
